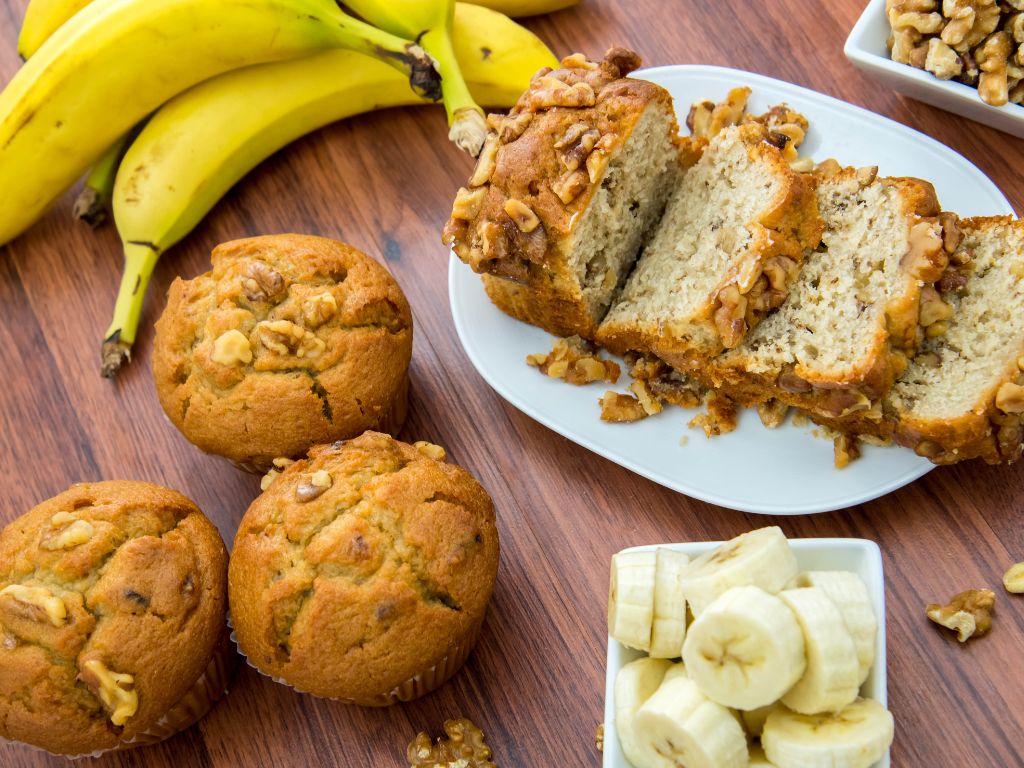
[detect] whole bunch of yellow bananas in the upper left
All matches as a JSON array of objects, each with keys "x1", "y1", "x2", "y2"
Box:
[{"x1": 0, "y1": 0, "x2": 564, "y2": 377}]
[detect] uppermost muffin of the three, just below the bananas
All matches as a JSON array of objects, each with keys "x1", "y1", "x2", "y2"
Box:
[{"x1": 153, "y1": 234, "x2": 413, "y2": 471}]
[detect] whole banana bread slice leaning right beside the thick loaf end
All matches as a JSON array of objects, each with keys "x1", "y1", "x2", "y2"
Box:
[{"x1": 598, "y1": 124, "x2": 822, "y2": 367}]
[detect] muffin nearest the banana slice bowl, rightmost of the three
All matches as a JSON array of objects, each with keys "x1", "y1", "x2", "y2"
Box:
[{"x1": 228, "y1": 432, "x2": 499, "y2": 706}]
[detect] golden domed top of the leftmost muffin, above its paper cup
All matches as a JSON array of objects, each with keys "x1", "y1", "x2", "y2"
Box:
[{"x1": 0, "y1": 480, "x2": 227, "y2": 755}]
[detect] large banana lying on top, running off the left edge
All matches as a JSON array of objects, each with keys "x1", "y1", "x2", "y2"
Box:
[{"x1": 0, "y1": 0, "x2": 440, "y2": 244}]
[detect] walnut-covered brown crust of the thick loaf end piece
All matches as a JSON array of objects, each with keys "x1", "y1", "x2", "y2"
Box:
[{"x1": 442, "y1": 48, "x2": 678, "y2": 338}]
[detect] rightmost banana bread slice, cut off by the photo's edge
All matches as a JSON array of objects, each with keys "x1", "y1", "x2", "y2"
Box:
[{"x1": 885, "y1": 216, "x2": 1024, "y2": 464}]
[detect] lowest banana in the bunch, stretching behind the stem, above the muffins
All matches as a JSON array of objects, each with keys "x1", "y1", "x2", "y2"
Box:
[{"x1": 102, "y1": 3, "x2": 557, "y2": 376}]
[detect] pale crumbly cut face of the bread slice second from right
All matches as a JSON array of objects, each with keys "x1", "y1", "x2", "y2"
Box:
[{"x1": 723, "y1": 176, "x2": 909, "y2": 382}]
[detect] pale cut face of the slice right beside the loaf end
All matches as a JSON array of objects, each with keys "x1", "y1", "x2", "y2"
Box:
[{"x1": 608, "y1": 129, "x2": 782, "y2": 350}]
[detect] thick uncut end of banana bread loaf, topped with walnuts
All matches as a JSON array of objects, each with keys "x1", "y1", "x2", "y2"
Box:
[{"x1": 443, "y1": 48, "x2": 680, "y2": 339}]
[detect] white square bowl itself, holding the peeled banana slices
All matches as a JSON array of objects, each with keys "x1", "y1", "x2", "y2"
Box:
[{"x1": 603, "y1": 539, "x2": 891, "y2": 768}]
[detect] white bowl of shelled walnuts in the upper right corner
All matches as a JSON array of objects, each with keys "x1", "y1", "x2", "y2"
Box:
[{"x1": 844, "y1": 0, "x2": 1024, "y2": 137}]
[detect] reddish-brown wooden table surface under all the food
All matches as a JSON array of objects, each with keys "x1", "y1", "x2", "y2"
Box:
[{"x1": 0, "y1": 0, "x2": 1024, "y2": 768}]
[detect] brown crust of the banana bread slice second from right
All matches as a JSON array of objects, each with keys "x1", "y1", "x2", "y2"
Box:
[{"x1": 700, "y1": 168, "x2": 945, "y2": 428}]
